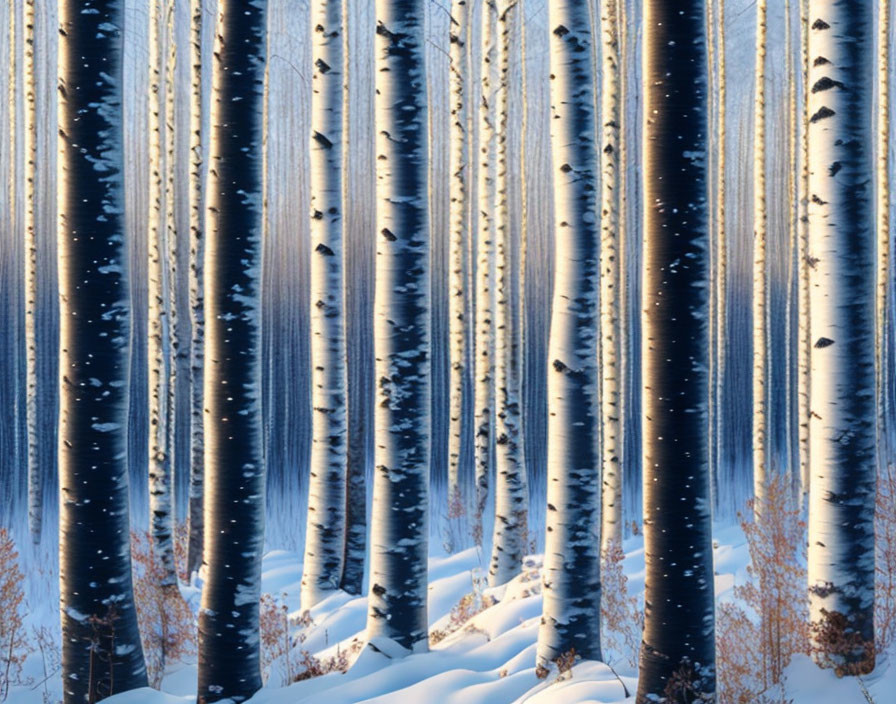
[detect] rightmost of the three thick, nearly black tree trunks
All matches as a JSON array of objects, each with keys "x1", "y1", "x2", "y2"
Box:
[{"x1": 637, "y1": 0, "x2": 715, "y2": 702}]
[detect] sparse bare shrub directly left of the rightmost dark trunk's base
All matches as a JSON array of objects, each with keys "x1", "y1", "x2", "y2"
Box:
[{"x1": 600, "y1": 543, "x2": 644, "y2": 667}]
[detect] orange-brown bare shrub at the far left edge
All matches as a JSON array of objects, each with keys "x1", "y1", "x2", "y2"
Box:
[{"x1": 0, "y1": 528, "x2": 30, "y2": 702}]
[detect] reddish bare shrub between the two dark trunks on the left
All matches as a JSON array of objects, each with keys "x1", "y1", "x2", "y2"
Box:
[{"x1": 131, "y1": 531, "x2": 196, "y2": 688}]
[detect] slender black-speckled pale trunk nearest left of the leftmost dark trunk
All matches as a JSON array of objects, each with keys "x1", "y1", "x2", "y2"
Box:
[{"x1": 22, "y1": 0, "x2": 43, "y2": 544}]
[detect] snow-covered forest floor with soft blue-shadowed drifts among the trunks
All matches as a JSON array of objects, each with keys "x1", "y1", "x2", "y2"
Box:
[{"x1": 9, "y1": 526, "x2": 896, "y2": 704}]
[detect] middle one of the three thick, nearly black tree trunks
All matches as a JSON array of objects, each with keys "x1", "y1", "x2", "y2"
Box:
[{"x1": 197, "y1": 0, "x2": 267, "y2": 704}]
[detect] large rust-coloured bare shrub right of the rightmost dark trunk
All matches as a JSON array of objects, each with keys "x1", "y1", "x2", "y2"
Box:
[{"x1": 716, "y1": 475, "x2": 809, "y2": 704}]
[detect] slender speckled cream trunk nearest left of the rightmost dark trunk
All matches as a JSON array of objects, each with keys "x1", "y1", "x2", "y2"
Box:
[{"x1": 600, "y1": 0, "x2": 624, "y2": 555}]
